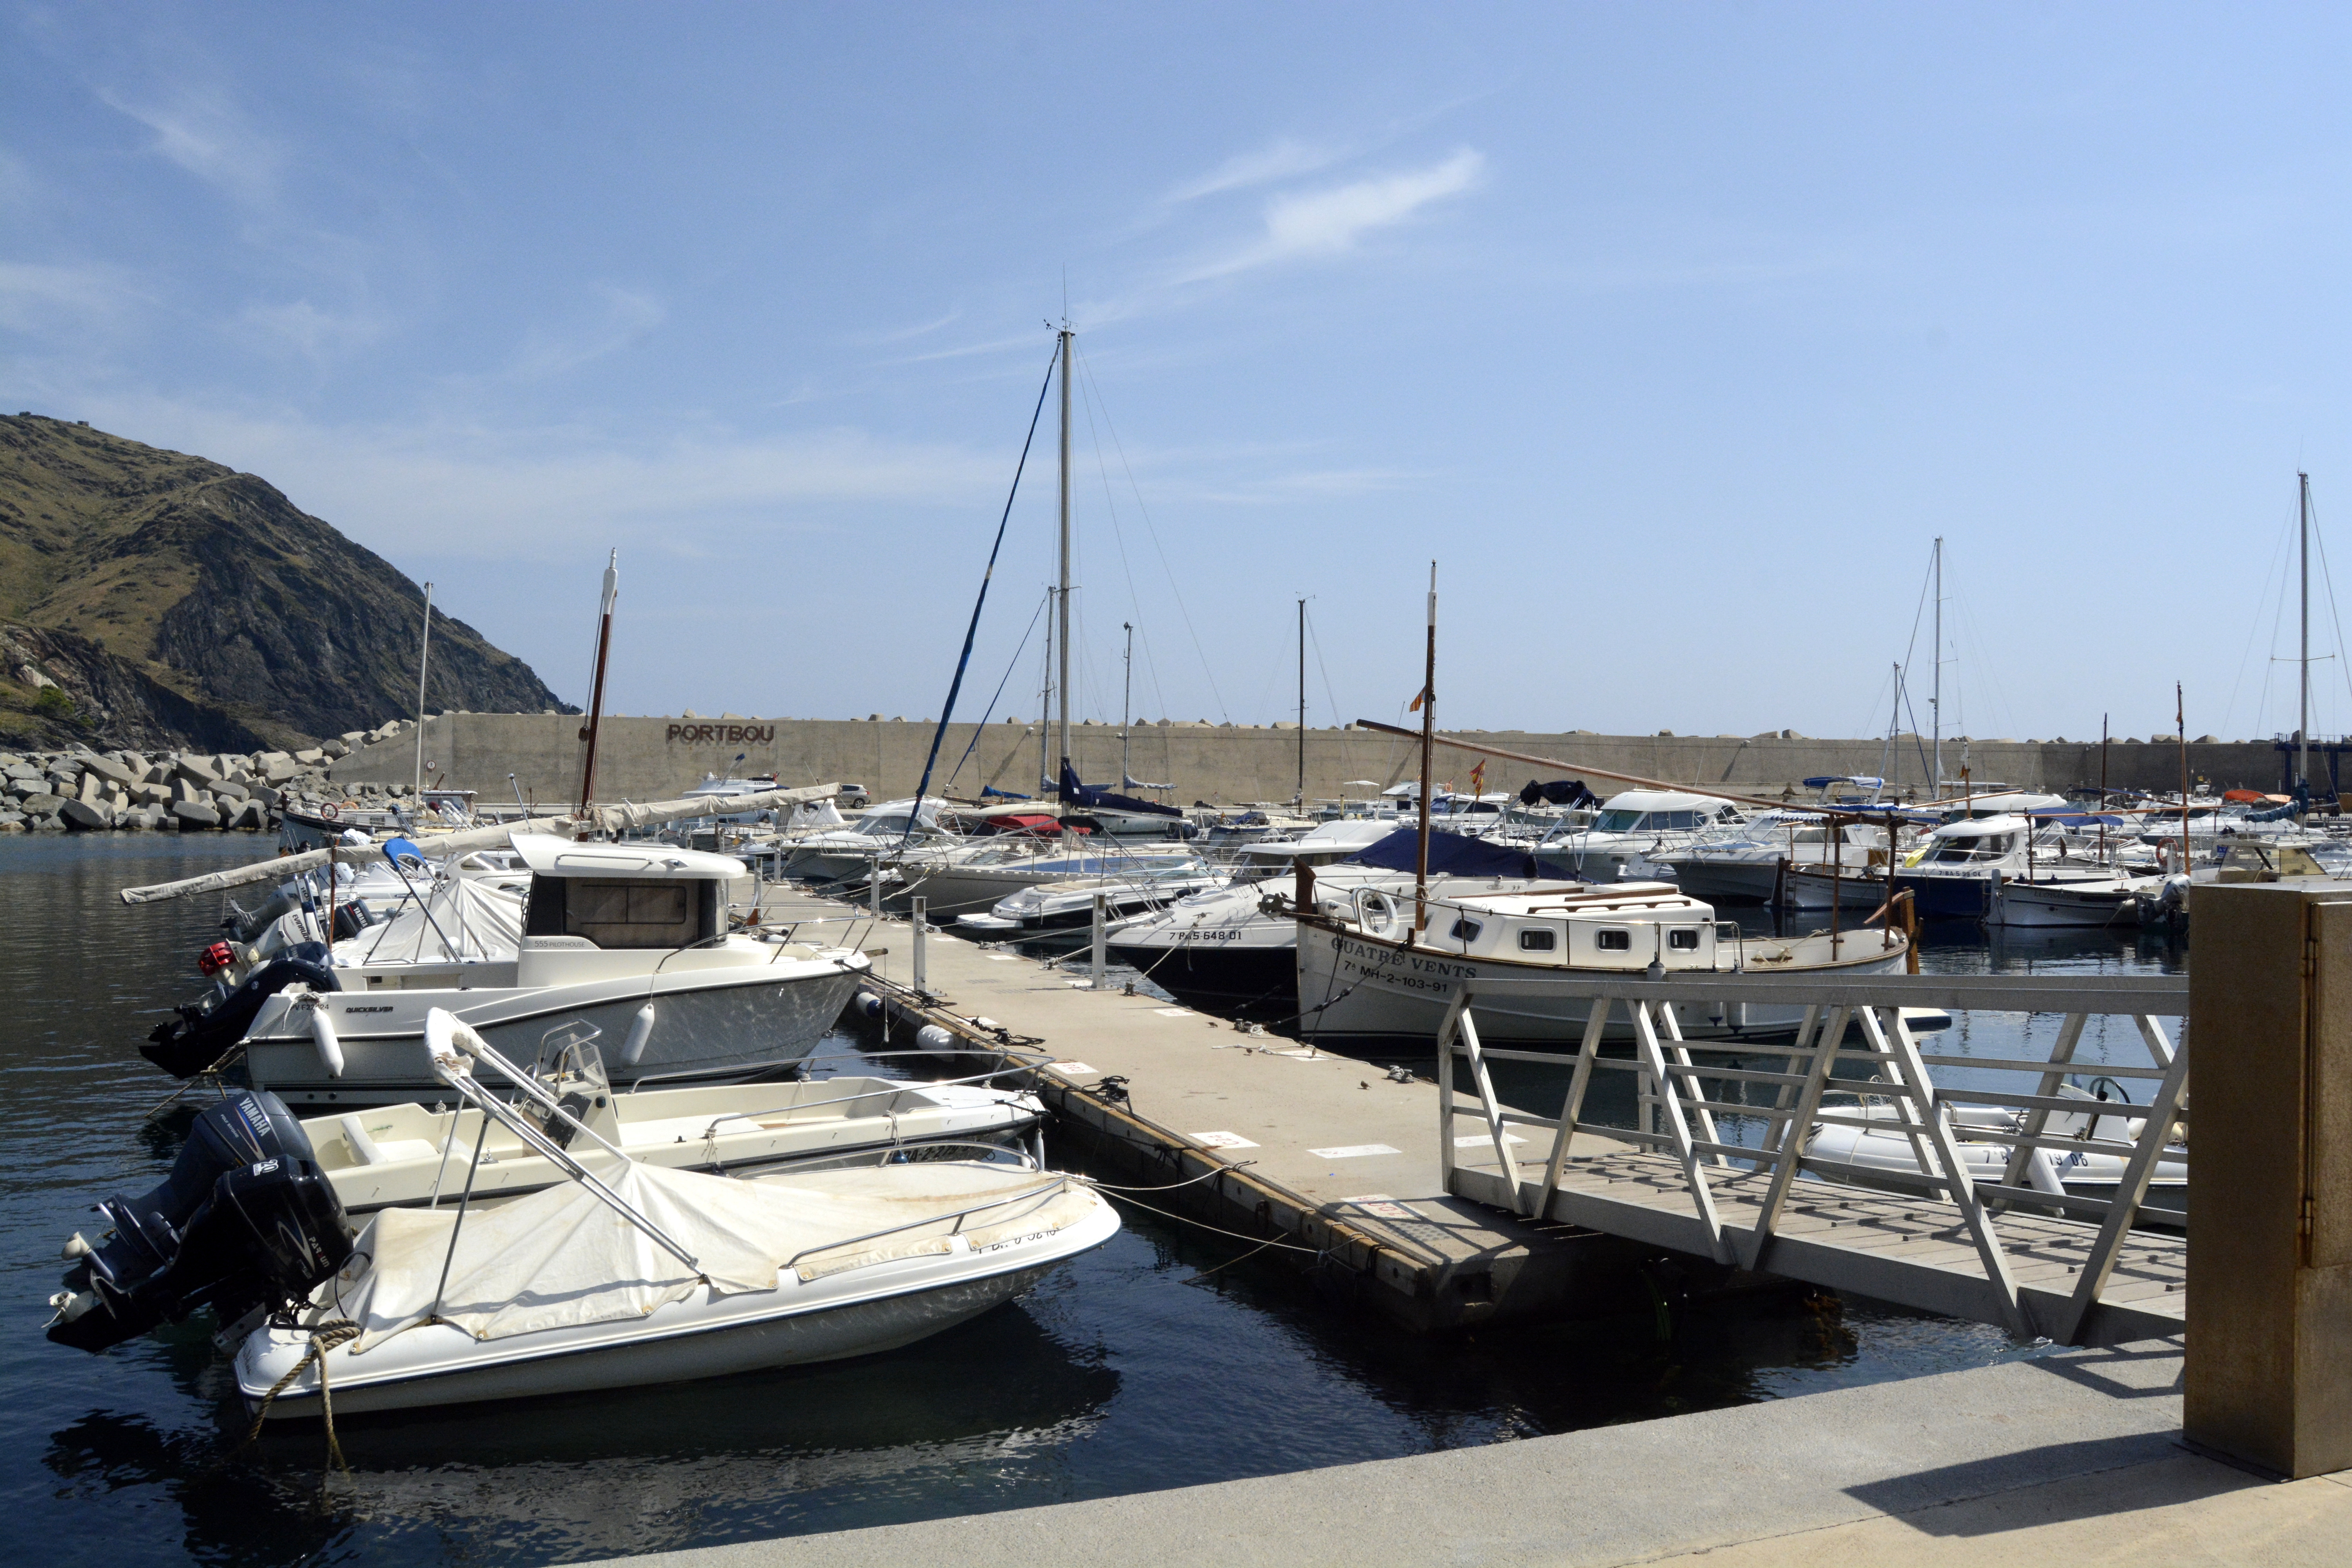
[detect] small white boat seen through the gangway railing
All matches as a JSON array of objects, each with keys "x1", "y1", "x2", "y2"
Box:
[{"x1": 1804, "y1": 1084, "x2": 2190, "y2": 1225}]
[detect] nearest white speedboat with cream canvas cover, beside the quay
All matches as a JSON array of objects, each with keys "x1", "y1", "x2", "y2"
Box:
[{"x1": 235, "y1": 1013, "x2": 1120, "y2": 1417}]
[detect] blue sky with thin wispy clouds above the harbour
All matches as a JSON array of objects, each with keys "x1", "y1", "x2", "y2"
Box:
[{"x1": 0, "y1": 5, "x2": 2352, "y2": 738}]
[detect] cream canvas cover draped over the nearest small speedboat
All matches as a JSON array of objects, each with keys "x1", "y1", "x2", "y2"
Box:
[{"x1": 332, "y1": 1157, "x2": 1082, "y2": 1354}]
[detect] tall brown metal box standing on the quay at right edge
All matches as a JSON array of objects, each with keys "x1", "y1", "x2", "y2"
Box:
[{"x1": 2183, "y1": 877, "x2": 2352, "y2": 1479}]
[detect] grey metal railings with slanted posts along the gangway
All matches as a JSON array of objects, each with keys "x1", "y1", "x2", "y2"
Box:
[{"x1": 1437, "y1": 973, "x2": 2190, "y2": 1345}]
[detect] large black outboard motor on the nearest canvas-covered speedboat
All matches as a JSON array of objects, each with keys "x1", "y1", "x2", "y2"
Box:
[{"x1": 49, "y1": 1089, "x2": 350, "y2": 1352}]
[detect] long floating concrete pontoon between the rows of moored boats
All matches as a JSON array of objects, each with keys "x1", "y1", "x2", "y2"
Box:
[{"x1": 762, "y1": 889, "x2": 1722, "y2": 1330}]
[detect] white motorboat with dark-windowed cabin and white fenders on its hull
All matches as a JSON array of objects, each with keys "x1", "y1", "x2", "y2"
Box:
[{"x1": 214, "y1": 832, "x2": 870, "y2": 1110}]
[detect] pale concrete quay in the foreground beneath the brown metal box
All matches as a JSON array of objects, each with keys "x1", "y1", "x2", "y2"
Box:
[{"x1": 602, "y1": 1340, "x2": 2352, "y2": 1568}]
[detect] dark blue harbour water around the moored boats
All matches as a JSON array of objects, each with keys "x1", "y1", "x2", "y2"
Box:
[{"x1": 0, "y1": 835, "x2": 2178, "y2": 1568}]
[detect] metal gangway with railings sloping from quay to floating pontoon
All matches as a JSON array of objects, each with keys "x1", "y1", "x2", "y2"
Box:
[{"x1": 1437, "y1": 973, "x2": 2190, "y2": 1345}]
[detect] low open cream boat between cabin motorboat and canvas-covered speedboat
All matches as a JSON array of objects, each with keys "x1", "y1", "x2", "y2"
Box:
[{"x1": 301, "y1": 1067, "x2": 1044, "y2": 1213}]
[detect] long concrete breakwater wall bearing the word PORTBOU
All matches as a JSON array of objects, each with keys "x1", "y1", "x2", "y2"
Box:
[{"x1": 329, "y1": 712, "x2": 2279, "y2": 804}]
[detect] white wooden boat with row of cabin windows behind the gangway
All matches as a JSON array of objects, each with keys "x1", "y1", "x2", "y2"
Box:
[{"x1": 1298, "y1": 882, "x2": 1919, "y2": 1044}]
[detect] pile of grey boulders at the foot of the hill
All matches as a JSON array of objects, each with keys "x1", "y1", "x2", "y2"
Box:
[{"x1": 0, "y1": 729, "x2": 379, "y2": 832}]
